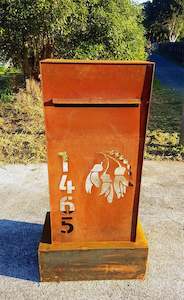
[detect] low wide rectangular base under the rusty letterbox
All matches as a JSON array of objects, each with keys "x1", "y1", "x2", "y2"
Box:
[{"x1": 38, "y1": 213, "x2": 148, "y2": 281}]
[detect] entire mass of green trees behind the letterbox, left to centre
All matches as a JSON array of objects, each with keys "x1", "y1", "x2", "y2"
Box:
[{"x1": 0, "y1": 0, "x2": 145, "y2": 77}]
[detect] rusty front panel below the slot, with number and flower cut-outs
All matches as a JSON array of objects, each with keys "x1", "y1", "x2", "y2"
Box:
[{"x1": 46, "y1": 106, "x2": 140, "y2": 242}]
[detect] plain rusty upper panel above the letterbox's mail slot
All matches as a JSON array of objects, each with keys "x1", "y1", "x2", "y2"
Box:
[{"x1": 41, "y1": 62, "x2": 152, "y2": 104}]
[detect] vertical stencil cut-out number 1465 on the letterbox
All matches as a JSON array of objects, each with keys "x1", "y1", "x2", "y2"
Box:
[{"x1": 58, "y1": 152, "x2": 75, "y2": 233}]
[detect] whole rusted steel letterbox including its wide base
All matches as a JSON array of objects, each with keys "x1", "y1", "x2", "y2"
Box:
[{"x1": 39, "y1": 59, "x2": 154, "y2": 280}]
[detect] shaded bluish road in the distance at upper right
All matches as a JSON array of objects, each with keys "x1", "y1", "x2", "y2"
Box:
[{"x1": 150, "y1": 54, "x2": 184, "y2": 94}]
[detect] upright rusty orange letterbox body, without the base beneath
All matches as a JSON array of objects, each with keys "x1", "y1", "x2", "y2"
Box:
[{"x1": 41, "y1": 60, "x2": 154, "y2": 243}]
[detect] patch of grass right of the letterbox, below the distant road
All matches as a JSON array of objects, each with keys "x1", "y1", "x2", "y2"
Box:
[{"x1": 145, "y1": 80, "x2": 184, "y2": 160}]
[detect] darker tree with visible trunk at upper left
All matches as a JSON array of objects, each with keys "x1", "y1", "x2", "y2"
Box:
[{"x1": 0, "y1": 0, "x2": 87, "y2": 77}]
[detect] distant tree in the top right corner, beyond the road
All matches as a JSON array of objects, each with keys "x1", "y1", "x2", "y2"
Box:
[{"x1": 145, "y1": 0, "x2": 184, "y2": 42}]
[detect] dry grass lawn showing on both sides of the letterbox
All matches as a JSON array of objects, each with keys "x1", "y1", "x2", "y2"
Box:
[{"x1": 0, "y1": 80, "x2": 184, "y2": 164}]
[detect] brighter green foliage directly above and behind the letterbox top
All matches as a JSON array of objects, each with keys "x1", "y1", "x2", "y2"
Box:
[{"x1": 58, "y1": 0, "x2": 145, "y2": 60}]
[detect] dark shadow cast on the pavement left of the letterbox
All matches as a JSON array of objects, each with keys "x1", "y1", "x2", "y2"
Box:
[{"x1": 0, "y1": 220, "x2": 43, "y2": 282}]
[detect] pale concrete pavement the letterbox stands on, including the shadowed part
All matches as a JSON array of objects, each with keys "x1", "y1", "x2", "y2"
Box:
[{"x1": 0, "y1": 161, "x2": 184, "y2": 300}]
